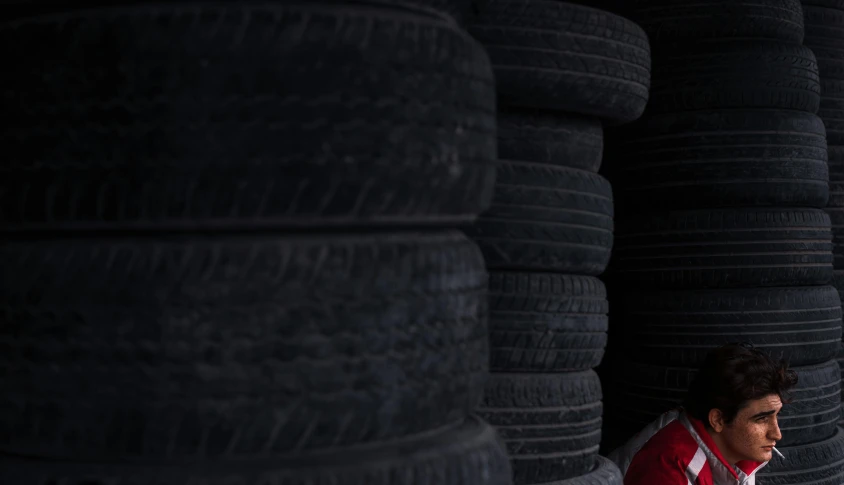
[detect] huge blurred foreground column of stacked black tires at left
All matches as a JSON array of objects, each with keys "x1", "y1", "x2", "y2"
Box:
[{"x1": 0, "y1": 2, "x2": 511, "y2": 485}]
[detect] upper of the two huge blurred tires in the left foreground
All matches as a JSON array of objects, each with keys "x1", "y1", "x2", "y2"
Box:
[{"x1": 0, "y1": 2, "x2": 496, "y2": 231}]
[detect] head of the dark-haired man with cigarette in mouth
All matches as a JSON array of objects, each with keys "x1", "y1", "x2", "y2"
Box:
[{"x1": 683, "y1": 344, "x2": 797, "y2": 464}]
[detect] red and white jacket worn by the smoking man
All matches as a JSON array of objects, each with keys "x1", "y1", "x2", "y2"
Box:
[{"x1": 609, "y1": 410, "x2": 768, "y2": 485}]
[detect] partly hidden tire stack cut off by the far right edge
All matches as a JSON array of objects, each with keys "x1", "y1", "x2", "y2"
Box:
[{"x1": 803, "y1": 0, "x2": 844, "y2": 424}]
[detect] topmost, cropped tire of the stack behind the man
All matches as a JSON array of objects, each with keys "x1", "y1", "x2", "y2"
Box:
[{"x1": 630, "y1": 0, "x2": 804, "y2": 44}]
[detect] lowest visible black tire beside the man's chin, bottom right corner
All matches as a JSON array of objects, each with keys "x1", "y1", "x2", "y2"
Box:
[{"x1": 756, "y1": 428, "x2": 844, "y2": 485}]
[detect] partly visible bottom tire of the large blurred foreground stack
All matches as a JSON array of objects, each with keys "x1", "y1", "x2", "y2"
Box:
[{"x1": 0, "y1": 418, "x2": 512, "y2": 485}]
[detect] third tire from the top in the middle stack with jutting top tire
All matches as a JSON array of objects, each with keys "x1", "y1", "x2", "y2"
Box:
[{"x1": 466, "y1": 160, "x2": 613, "y2": 276}]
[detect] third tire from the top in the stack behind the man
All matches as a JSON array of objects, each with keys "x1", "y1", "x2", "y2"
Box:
[{"x1": 613, "y1": 110, "x2": 829, "y2": 209}]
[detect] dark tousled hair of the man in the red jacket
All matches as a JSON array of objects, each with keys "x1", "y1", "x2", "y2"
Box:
[{"x1": 683, "y1": 343, "x2": 797, "y2": 427}]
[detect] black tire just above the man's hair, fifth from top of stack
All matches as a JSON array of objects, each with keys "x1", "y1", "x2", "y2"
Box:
[{"x1": 620, "y1": 286, "x2": 842, "y2": 367}]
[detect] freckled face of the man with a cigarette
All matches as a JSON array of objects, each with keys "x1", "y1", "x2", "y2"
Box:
[{"x1": 720, "y1": 394, "x2": 782, "y2": 461}]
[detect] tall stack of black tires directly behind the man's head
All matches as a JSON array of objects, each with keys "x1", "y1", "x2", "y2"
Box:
[{"x1": 608, "y1": 0, "x2": 844, "y2": 485}]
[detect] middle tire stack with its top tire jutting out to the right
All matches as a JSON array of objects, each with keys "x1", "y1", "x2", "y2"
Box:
[{"x1": 468, "y1": 0, "x2": 650, "y2": 485}]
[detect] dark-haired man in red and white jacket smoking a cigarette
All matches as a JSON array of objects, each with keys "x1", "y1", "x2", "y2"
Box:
[{"x1": 610, "y1": 344, "x2": 797, "y2": 485}]
